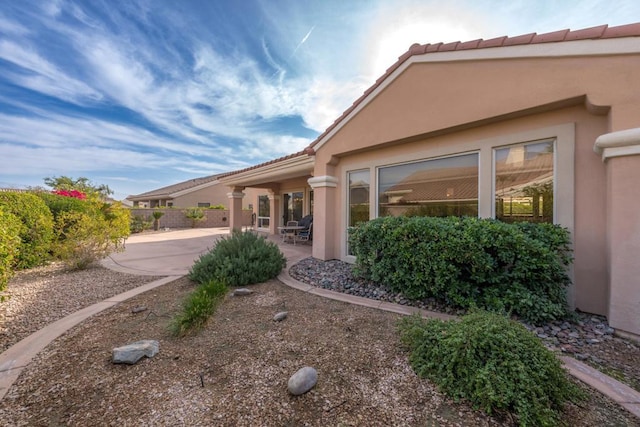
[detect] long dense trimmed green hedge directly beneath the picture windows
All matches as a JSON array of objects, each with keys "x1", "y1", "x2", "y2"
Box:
[{"x1": 349, "y1": 217, "x2": 572, "y2": 323}]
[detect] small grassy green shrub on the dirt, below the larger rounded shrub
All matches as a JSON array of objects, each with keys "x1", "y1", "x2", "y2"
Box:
[{"x1": 169, "y1": 280, "x2": 228, "y2": 336}]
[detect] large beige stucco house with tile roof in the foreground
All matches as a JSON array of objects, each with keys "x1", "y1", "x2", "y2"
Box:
[{"x1": 220, "y1": 24, "x2": 640, "y2": 342}]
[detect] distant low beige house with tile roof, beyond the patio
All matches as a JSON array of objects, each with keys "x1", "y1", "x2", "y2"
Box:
[{"x1": 127, "y1": 175, "x2": 258, "y2": 209}]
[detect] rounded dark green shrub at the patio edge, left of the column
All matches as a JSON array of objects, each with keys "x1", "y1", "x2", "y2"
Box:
[{"x1": 189, "y1": 230, "x2": 287, "y2": 286}]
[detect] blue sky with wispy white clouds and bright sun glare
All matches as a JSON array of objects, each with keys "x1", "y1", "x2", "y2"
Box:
[{"x1": 0, "y1": 0, "x2": 640, "y2": 199}]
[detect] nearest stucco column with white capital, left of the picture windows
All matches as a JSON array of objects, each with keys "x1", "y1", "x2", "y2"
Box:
[{"x1": 307, "y1": 175, "x2": 340, "y2": 261}]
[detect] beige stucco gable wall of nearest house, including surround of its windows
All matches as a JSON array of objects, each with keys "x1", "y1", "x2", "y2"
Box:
[{"x1": 314, "y1": 49, "x2": 640, "y2": 324}]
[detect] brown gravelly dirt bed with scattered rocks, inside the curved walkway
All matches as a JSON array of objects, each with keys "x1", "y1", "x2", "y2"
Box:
[{"x1": 0, "y1": 278, "x2": 640, "y2": 426}]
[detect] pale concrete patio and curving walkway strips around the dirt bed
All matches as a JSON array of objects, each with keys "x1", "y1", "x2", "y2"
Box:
[{"x1": 0, "y1": 228, "x2": 640, "y2": 418}]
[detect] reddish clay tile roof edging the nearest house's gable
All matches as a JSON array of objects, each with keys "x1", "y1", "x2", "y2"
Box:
[{"x1": 224, "y1": 22, "x2": 640, "y2": 181}]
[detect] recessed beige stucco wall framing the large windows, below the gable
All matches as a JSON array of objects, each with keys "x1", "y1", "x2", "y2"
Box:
[{"x1": 330, "y1": 106, "x2": 607, "y2": 314}]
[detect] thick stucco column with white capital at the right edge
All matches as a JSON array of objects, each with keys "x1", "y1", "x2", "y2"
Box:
[{"x1": 594, "y1": 128, "x2": 640, "y2": 337}]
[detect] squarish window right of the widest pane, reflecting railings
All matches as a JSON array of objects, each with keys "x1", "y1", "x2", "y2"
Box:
[{"x1": 494, "y1": 140, "x2": 554, "y2": 223}]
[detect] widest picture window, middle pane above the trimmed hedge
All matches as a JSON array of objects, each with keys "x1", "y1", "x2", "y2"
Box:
[{"x1": 378, "y1": 153, "x2": 478, "y2": 217}]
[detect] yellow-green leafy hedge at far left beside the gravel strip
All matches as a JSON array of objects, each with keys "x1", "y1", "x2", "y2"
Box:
[{"x1": 0, "y1": 191, "x2": 130, "y2": 280}]
